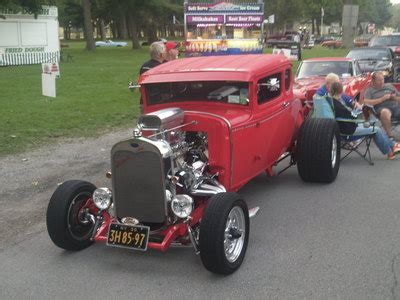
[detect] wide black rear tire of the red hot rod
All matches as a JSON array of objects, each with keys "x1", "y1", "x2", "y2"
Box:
[{"x1": 296, "y1": 119, "x2": 340, "y2": 183}]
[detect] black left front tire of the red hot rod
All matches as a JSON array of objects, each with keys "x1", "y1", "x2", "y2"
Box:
[{"x1": 46, "y1": 180, "x2": 96, "y2": 251}]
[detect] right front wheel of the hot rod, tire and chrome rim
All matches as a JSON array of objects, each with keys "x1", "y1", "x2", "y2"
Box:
[{"x1": 199, "y1": 193, "x2": 250, "y2": 275}]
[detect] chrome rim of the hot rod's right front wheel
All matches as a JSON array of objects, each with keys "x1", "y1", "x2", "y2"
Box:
[{"x1": 224, "y1": 206, "x2": 246, "y2": 263}]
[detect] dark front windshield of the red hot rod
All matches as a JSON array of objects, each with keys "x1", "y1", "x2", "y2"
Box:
[{"x1": 145, "y1": 81, "x2": 249, "y2": 105}]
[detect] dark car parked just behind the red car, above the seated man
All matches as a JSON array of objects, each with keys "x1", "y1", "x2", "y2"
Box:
[{"x1": 346, "y1": 47, "x2": 398, "y2": 82}]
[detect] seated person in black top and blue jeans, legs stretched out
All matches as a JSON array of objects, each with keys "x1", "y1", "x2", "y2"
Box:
[{"x1": 329, "y1": 82, "x2": 400, "y2": 160}]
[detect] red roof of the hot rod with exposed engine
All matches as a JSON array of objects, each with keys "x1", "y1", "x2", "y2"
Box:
[{"x1": 140, "y1": 54, "x2": 291, "y2": 83}]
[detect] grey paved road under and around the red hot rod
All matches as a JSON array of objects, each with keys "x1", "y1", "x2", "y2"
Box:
[{"x1": 0, "y1": 131, "x2": 400, "y2": 299}]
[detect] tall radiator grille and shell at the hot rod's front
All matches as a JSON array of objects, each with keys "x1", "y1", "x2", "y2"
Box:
[{"x1": 111, "y1": 138, "x2": 169, "y2": 223}]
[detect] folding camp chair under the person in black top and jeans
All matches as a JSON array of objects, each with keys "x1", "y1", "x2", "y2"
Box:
[{"x1": 336, "y1": 118, "x2": 377, "y2": 165}]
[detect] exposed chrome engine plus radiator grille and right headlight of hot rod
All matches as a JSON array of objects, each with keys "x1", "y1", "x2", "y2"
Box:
[{"x1": 111, "y1": 108, "x2": 226, "y2": 224}]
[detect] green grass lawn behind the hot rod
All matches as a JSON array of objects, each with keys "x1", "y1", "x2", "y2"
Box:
[{"x1": 0, "y1": 42, "x2": 346, "y2": 156}]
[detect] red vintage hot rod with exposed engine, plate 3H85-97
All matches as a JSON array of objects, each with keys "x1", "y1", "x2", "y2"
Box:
[{"x1": 47, "y1": 55, "x2": 340, "y2": 274}]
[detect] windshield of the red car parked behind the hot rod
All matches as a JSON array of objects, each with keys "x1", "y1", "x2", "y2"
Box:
[{"x1": 297, "y1": 61, "x2": 354, "y2": 78}]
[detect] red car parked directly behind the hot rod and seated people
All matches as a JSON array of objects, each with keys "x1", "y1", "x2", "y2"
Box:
[{"x1": 294, "y1": 57, "x2": 371, "y2": 101}]
